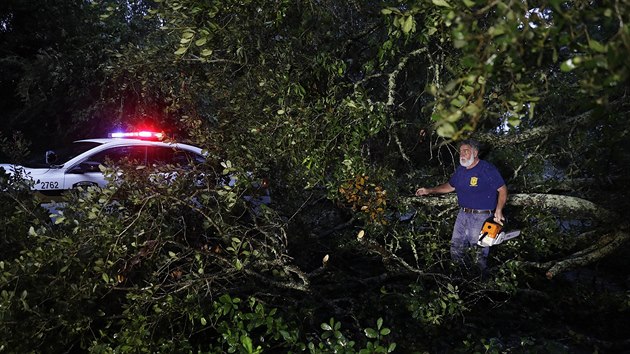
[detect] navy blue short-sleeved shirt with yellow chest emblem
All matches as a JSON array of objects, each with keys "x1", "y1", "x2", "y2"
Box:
[{"x1": 448, "y1": 160, "x2": 505, "y2": 210}]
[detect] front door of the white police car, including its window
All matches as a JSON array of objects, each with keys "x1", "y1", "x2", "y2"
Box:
[{"x1": 64, "y1": 145, "x2": 147, "y2": 189}]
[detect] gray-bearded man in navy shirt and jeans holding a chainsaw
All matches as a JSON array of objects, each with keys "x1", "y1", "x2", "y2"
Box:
[{"x1": 416, "y1": 140, "x2": 507, "y2": 271}]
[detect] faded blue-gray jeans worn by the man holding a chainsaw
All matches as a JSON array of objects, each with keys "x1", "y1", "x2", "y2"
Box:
[{"x1": 451, "y1": 210, "x2": 492, "y2": 271}]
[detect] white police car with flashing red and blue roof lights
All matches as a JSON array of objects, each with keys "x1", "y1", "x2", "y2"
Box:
[{"x1": 0, "y1": 131, "x2": 205, "y2": 200}]
